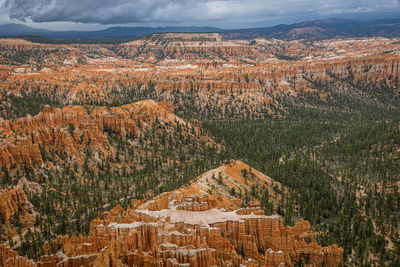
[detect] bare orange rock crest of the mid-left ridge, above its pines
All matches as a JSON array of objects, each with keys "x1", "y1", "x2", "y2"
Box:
[{"x1": 0, "y1": 100, "x2": 188, "y2": 174}]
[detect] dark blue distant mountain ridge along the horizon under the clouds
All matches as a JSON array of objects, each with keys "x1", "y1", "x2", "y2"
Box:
[{"x1": 0, "y1": 18, "x2": 400, "y2": 40}]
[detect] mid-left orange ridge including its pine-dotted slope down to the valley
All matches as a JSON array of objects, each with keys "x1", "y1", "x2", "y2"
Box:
[{"x1": 0, "y1": 100, "x2": 223, "y2": 260}]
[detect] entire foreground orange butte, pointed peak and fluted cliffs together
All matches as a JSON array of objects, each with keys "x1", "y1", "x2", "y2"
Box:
[{"x1": 0, "y1": 161, "x2": 343, "y2": 267}]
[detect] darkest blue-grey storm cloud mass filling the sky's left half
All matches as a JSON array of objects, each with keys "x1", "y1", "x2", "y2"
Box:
[{"x1": 8, "y1": 0, "x2": 189, "y2": 24}]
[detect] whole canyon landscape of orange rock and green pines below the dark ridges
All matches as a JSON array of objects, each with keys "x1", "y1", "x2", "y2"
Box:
[{"x1": 0, "y1": 33, "x2": 400, "y2": 266}]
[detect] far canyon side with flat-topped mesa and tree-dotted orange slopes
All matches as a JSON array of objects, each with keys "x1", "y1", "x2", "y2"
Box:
[{"x1": 0, "y1": 34, "x2": 399, "y2": 118}]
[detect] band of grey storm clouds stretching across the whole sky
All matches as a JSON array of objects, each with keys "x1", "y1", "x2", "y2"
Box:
[{"x1": 0, "y1": 0, "x2": 400, "y2": 24}]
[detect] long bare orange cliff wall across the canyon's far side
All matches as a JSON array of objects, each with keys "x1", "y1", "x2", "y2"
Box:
[{"x1": 0, "y1": 35, "x2": 400, "y2": 111}]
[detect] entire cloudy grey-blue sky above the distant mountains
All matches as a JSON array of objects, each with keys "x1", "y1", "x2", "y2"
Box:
[{"x1": 0, "y1": 0, "x2": 400, "y2": 30}]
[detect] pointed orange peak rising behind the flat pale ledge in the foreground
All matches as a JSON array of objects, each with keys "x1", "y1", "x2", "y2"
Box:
[{"x1": 141, "y1": 161, "x2": 287, "y2": 215}]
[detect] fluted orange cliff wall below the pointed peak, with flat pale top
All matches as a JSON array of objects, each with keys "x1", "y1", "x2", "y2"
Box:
[{"x1": 0, "y1": 198, "x2": 343, "y2": 267}]
